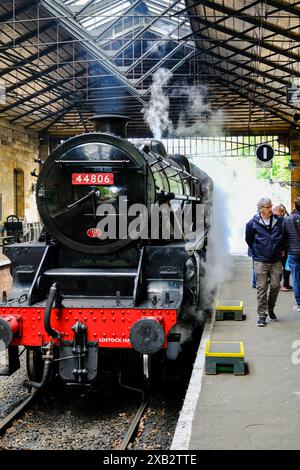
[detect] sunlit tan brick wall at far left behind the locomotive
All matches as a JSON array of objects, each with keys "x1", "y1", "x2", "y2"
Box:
[{"x1": 0, "y1": 119, "x2": 39, "y2": 223}]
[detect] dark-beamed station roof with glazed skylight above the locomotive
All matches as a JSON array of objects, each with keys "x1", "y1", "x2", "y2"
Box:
[{"x1": 0, "y1": 0, "x2": 300, "y2": 138}]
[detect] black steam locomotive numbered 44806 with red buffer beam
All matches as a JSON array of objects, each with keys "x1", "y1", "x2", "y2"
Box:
[{"x1": 0, "y1": 115, "x2": 213, "y2": 388}]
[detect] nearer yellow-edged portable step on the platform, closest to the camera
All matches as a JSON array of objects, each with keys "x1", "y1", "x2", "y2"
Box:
[{"x1": 205, "y1": 341, "x2": 245, "y2": 375}]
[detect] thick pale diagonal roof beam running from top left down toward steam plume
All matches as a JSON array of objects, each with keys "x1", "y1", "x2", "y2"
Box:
[{"x1": 40, "y1": 0, "x2": 145, "y2": 106}]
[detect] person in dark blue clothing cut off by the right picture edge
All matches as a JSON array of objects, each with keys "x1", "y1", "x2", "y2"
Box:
[{"x1": 283, "y1": 197, "x2": 300, "y2": 312}]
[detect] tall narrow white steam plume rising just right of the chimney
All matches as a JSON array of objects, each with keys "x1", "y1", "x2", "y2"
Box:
[{"x1": 142, "y1": 68, "x2": 172, "y2": 140}]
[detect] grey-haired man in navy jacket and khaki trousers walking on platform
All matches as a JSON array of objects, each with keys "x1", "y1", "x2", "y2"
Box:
[{"x1": 246, "y1": 197, "x2": 283, "y2": 326}]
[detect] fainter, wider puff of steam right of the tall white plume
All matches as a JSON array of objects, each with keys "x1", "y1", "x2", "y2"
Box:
[{"x1": 175, "y1": 85, "x2": 224, "y2": 137}]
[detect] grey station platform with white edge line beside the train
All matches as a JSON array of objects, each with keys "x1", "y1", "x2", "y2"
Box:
[{"x1": 171, "y1": 256, "x2": 300, "y2": 450}]
